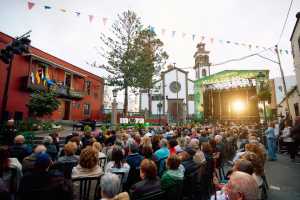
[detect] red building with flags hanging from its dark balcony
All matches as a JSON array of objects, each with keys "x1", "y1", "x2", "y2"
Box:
[{"x1": 0, "y1": 32, "x2": 104, "y2": 120}]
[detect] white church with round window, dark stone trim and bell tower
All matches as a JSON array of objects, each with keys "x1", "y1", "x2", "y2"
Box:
[{"x1": 140, "y1": 43, "x2": 210, "y2": 122}]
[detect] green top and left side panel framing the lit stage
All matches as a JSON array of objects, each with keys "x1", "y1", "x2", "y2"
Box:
[{"x1": 194, "y1": 70, "x2": 269, "y2": 121}]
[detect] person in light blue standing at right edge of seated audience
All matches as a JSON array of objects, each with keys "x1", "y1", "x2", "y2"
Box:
[{"x1": 265, "y1": 122, "x2": 277, "y2": 161}]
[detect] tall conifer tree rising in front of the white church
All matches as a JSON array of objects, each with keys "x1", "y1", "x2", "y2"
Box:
[{"x1": 93, "y1": 11, "x2": 166, "y2": 115}]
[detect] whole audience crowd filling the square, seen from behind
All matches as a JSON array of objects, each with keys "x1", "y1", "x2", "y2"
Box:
[{"x1": 0, "y1": 119, "x2": 296, "y2": 200}]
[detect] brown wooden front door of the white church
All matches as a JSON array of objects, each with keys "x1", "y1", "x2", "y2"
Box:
[{"x1": 168, "y1": 99, "x2": 183, "y2": 122}]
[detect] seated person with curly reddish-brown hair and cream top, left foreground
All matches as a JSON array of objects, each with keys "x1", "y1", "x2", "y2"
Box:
[{"x1": 72, "y1": 146, "x2": 103, "y2": 178}]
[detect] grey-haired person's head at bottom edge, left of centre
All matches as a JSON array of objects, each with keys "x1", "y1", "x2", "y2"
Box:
[{"x1": 100, "y1": 173, "x2": 129, "y2": 200}]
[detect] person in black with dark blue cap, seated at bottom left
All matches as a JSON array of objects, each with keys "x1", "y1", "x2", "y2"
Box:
[{"x1": 18, "y1": 153, "x2": 73, "y2": 200}]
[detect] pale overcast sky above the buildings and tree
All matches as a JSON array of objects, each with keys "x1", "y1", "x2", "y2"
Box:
[{"x1": 0, "y1": 0, "x2": 300, "y2": 108}]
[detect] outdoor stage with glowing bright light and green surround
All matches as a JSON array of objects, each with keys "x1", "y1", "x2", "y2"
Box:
[{"x1": 195, "y1": 70, "x2": 269, "y2": 122}]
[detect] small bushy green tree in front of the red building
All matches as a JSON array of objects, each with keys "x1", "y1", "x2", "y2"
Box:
[{"x1": 26, "y1": 90, "x2": 60, "y2": 117}]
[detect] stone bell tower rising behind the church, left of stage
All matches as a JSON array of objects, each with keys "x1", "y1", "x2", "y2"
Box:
[{"x1": 194, "y1": 42, "x2": 210, "y2": 80}]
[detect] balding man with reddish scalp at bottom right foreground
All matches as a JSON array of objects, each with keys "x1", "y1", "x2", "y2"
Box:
[{"x1": 211, "y1": 171, "x2": 258, "y2": 200}]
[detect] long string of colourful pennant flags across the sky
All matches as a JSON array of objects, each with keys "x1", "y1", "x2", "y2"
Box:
[{"x1": 27, "y1": 1, "x2": 291, "y2": 55}]
